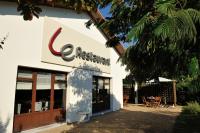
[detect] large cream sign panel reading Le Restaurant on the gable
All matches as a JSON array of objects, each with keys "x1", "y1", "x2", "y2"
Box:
[{"x1": 41, "y1": 17, "x2": 111, "y2": 73}]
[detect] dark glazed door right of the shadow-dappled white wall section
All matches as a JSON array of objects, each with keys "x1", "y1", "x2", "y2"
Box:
[{"x1": 92, "y1": 76, "x2": 110, "y2": 113}]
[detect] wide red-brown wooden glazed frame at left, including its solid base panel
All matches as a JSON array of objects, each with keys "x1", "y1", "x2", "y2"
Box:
[{"x1": 14, "y1": 68, "x2": 67, "y2": 132}]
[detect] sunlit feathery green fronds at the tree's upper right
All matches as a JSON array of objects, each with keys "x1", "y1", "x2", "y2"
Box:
[{"x1": 127, "y1": 0, "x2": 200, "y2": 43}]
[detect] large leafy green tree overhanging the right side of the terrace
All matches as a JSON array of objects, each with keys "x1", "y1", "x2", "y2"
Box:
[{"x1": 103, "y1": 0, "x2": 200, "y2": 81}]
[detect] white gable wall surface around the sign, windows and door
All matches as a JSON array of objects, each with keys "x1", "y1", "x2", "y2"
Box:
[{"x1": 0, "y1": 2, "x2": 124, "y2": 133}]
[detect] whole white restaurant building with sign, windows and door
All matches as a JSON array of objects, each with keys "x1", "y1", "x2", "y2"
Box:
[{"x1": 0, "y1": 1, "x2": 125, "y2": 133}]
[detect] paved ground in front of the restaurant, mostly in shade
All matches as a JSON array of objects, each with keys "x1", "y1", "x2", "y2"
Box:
[{"x1": 38, "y1": 104, "x2": 181, "y2": 133}]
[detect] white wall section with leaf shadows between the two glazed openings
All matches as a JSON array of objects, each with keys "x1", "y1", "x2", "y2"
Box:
[{"x1": 67, "y1": 65, "x2": 110, "y2": 123}]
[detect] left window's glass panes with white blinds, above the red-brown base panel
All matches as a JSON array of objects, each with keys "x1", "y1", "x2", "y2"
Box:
[{"x1": 15, "y1": 68, "x2": 67, "y2": 114}]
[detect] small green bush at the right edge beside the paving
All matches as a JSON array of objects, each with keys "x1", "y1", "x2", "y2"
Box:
[{"x1": 182, "y1": 102, "x2": 200, "y2": 115}]
